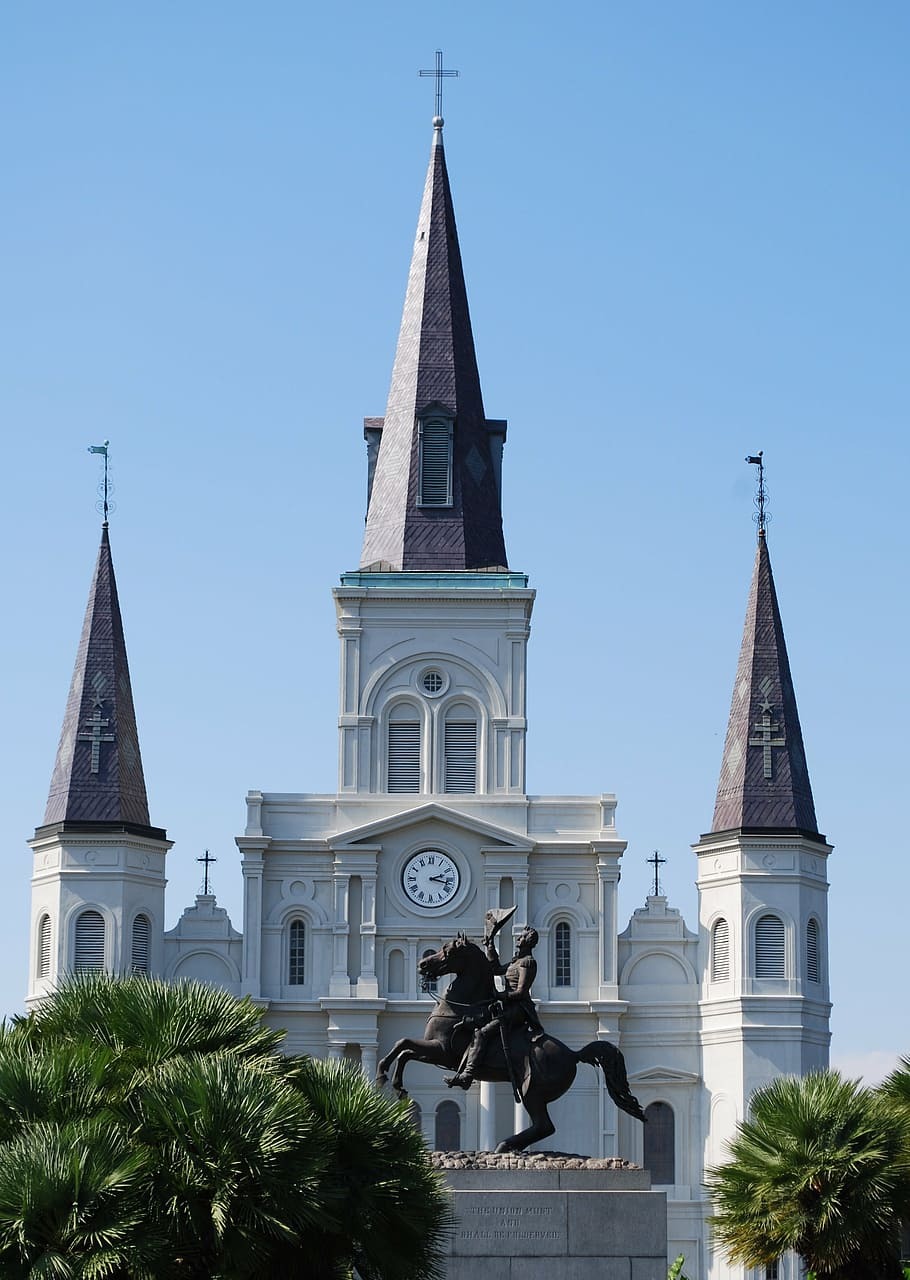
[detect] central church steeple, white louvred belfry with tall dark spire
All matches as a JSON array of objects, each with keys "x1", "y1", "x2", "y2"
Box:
[{"x1": 334, "y1": 116, "x2": 534, "y2": 797}]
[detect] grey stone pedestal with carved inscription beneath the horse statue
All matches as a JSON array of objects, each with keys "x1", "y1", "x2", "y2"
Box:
[{"x1": 434, "y1": 1152, "x2": 667, "y2": 1280}]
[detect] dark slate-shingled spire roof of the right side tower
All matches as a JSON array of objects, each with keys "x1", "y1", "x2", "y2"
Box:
[{"x1": 712, "y1": 530, "x2": 824, "y2": 840}]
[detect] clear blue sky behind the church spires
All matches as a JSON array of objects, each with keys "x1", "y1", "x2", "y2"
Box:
[{"x1": 0, "y1": 0, "x2": 910, "y2": 1073}]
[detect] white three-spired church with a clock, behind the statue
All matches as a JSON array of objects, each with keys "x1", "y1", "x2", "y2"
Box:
[{"x1": 28, "y1": 112, "x2": 831, "y2": 1280}]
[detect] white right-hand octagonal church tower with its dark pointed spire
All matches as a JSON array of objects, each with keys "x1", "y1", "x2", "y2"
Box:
[{"x1": 694, "y1": 496, "x2": 832, "y2": 1277}]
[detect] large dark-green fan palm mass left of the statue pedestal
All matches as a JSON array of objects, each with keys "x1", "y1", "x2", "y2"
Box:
[{"x1": 0, "y1": 974, "x2": 448, "y2": 1280}]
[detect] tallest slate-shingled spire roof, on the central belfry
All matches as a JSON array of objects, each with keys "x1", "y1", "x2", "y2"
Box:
[{"x1": 361, "y1": 116, "x2": 507, "y2": 571}]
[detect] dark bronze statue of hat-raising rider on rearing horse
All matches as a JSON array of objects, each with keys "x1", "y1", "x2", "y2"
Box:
[{"x1": 376, "y1": 908, "x2": 645, "y2": 1151}]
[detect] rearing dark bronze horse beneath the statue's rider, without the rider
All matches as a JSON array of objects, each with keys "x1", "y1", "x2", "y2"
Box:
[{"x1": 376, "y1": 934, "x2": 645, "y2": 1151}]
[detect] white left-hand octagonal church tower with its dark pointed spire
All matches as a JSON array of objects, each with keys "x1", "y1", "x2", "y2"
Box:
[{"x1": 27, "y1": 521, "x2": 170, "y2": 1004}]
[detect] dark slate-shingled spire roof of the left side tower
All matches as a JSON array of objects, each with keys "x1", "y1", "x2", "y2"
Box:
[{"x1": 39, "y1": 524, "x2": 163, "y2": 836}]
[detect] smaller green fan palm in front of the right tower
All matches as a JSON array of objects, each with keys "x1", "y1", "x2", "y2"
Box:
[{"x1": 706, "y1": 1071, "x2": 910, "y2": 1280}]
